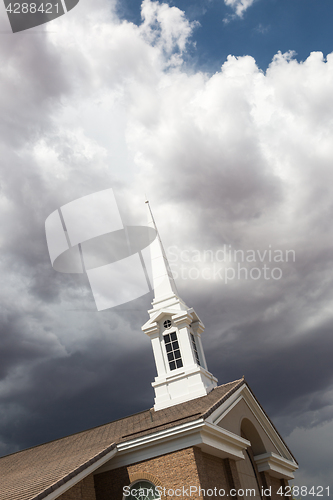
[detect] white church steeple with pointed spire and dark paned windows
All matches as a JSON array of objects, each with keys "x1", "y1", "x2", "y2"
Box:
[{"x1": 142, "y1": 202, "x2": 217, "y2": 410}]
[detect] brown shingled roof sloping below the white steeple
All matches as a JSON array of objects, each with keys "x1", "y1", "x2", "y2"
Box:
[{"x1": 0, "y1": 379, "x2": 245, "y2": 500}]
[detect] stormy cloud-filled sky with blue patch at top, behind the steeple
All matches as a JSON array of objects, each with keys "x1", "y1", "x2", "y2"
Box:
[{"x1": 0, "y1": 0, "x2": 333, "y2": 491}]
